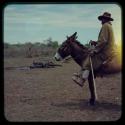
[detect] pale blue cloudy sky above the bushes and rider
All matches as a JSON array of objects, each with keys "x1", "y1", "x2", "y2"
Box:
[{"x1": 3, "y1": 3, "x2": 122, "y2": 44}]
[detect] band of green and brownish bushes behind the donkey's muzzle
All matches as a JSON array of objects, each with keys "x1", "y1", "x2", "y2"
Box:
[{"x1": 4, "y1": 41, "x2": 58, "y2": 58}]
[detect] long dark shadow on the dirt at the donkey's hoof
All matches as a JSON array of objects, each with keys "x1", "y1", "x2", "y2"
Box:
[{"x1": 51, "y1": 99, "x2": 121, "y2": 111}]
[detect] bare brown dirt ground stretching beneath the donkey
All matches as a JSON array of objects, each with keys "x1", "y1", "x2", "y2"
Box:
[{"x1": 4, "y1": 58, "x2": 122, "y2": 122}]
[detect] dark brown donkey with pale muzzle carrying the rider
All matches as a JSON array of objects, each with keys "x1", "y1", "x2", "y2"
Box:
[{"x1": 55, "y1": 32, "x2": 121, "y2": 105}]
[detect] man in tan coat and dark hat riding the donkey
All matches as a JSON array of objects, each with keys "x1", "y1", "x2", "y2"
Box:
[{"x1": 72, "y1": 12, "x2": 116, "y2": 87}]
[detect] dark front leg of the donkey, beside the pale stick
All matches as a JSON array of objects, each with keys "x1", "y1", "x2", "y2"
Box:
[{"x1": 88, "y1": 72, "x2": 97, "y2": 105}]
